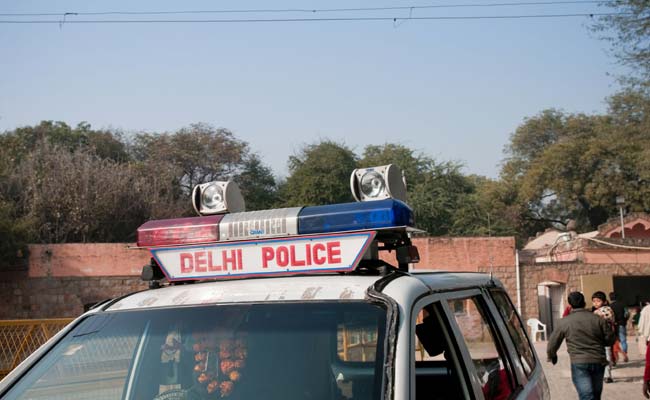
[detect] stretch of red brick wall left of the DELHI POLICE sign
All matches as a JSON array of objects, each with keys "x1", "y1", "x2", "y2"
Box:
[{"x1": 0, "y1": 243, "x2": 150, "y2": 319}]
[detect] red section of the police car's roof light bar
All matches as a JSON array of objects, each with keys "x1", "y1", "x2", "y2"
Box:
[{"x1": 137, "y1": 215, "x2": 223, "y2": 247}]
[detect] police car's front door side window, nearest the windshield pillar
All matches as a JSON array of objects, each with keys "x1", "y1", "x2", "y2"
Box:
[{"x1": 413, "y1": 304, "x2": 464, "y2": 400}]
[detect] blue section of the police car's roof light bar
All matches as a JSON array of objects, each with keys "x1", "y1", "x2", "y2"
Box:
[{"x1": 298, "y1": 199, "x2": 414, "y2": 235}]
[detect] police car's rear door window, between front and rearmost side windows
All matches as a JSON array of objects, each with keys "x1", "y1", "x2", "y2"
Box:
[{"x1": 449, "y1": 296, "x2": 513, "y2": 400}]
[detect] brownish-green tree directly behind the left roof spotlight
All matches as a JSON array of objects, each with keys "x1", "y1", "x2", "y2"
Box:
[{"x1": 130, "y1": 123, "x2": 277, "y2": 218}]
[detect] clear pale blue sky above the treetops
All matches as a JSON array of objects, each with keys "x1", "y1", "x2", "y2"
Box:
[{"x1": 0, "y1": 0, "x2": 621, "y2": 177}]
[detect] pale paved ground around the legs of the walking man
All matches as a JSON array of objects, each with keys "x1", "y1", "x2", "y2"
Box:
[{"x1": 535, "y1": 337, "x2": 645, "y2": 400}]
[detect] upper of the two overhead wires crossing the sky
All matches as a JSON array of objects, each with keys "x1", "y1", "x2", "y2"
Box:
[{"x1": 0, "y1": 0, "x2": 613, "y2": 17}]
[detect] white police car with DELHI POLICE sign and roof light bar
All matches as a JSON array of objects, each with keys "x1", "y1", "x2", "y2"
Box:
[{"x1": 0, "y1": 166, "x2": 549, "y2": 400}]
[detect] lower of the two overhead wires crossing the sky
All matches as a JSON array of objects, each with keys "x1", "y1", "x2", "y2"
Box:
[{"x1": 0, "y1": 13, "x2": 630, "y2": 25}]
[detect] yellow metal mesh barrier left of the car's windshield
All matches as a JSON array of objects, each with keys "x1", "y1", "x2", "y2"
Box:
[{"x1": 0, "y1": 318, "x2": 72, "y2": 379}]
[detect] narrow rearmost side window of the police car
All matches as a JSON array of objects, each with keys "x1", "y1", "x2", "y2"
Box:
[{"x1": 490, "y1": 290, "x2": 535, "y2": 376}]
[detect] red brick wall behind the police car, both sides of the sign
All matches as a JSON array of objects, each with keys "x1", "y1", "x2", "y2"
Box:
[{"x1": 0, "y1": 237, "x2": 516, "y2": 319}]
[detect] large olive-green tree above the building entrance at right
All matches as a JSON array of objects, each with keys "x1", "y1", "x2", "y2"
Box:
[{"x1": 502, "y1": 91, "x2": 650, "y2": 234}]
